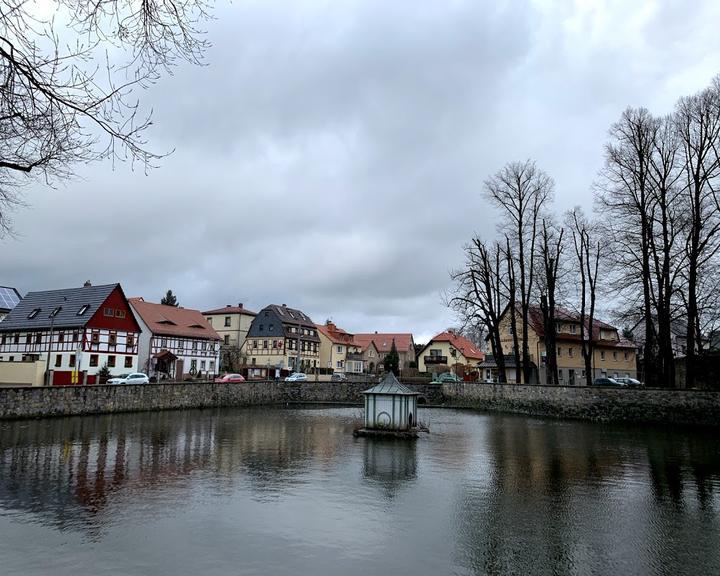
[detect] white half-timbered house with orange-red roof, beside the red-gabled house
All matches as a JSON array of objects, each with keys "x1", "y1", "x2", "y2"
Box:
[{"x1": 129, "y1": 298, "x2": 220, "y2": 380}]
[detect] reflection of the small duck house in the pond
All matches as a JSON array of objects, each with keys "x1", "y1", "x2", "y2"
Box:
[{"x1": 360, "y1": 438, "x2": 418, "y2": 499}]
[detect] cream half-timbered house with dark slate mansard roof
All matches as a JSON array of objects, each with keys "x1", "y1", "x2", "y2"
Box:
[{"x1": 241, "y1": 304, "x2": 320, "y2": 372}]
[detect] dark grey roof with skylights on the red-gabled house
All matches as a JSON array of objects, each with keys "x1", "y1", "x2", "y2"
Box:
[{"x1": 0, "y1": 284, "x2": 119, "y2": 332}]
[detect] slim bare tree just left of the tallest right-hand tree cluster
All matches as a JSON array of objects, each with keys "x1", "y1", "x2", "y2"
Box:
[{"x1": 566, "y1": 208, "x2": 600, "y2": 386}]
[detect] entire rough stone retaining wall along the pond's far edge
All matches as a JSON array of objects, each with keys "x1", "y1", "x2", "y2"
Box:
[{"x1": 0, "y1": 381, "x2": 720, "y2": 426}]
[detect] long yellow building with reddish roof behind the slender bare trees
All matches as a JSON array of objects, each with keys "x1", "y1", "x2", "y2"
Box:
[{"x1": 492, "y1": 306, "x2": 637, "y2": 386}]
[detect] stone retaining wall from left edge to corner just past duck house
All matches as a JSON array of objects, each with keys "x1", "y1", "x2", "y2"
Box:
[{"x1": 0, "y1": 381, "x2": 443, "y2": 419}]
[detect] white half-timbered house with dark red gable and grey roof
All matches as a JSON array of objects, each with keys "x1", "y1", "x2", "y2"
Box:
[{"x1": 0, "y1": 282, "x2": 141, "y2": 385}]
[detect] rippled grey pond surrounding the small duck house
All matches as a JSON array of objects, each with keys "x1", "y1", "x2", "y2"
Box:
[{"x1": 0, "y1": 408, "x2": 720, "y2": 576}]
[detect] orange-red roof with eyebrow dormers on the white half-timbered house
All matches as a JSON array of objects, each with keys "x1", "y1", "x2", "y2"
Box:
[{"x1": 129, "y1": 298, "x2": 220, "y2": 340}]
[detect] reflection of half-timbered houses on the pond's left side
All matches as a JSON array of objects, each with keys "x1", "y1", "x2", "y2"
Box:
[{"x1": 0, "y1": 409, "x2": 352, "y2": 533}]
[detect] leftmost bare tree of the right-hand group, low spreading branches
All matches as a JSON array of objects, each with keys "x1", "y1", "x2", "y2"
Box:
[{"x1": 447, "y1": 238, "x2": 507, "y2": 382}]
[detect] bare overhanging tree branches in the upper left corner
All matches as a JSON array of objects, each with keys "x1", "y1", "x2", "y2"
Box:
[{"x1": 0, "y1": 0, "x2": 208, "y2": 232}]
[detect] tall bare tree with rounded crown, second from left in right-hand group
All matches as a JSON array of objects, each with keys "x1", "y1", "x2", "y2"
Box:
[{"x1": 485, "y1": 160, "x2": 553, "y2": 384}]
